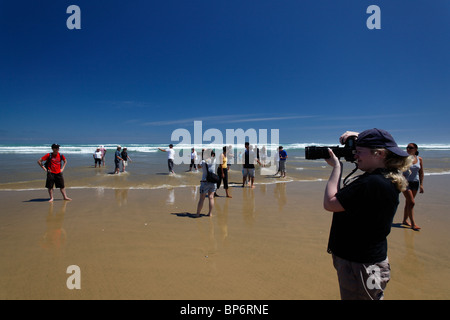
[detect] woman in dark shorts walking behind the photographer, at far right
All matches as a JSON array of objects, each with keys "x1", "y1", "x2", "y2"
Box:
[{"x1": 403, "y1": 143, "x2": 424, "y2": 231}]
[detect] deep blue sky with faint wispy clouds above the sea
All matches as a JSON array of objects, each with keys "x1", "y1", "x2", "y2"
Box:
[{"x1": 0, "y1": 0, "x2": 450, "y2": 143}]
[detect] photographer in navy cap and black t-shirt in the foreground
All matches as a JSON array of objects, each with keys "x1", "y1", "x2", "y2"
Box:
[{"x1": 324, "y1": 129, "x2": 411, "y2": 300}]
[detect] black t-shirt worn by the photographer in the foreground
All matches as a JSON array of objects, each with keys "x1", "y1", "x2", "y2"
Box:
[{"x1": 328, "y1": 169, "x2": 399, "y2": 263}]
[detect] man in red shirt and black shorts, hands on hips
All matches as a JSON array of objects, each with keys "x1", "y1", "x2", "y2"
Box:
[{"x1": 38, "y1": 144, "x2": 72, "y2": 202}]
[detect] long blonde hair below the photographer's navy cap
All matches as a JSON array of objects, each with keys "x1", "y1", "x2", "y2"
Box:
[{"x1": 372, "y1": 149, "x2": 413, "y2": 192}]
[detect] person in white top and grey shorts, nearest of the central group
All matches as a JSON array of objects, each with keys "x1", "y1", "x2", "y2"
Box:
[{"x1": 195, "y1": 149, "x2": 217, "y2": 217}]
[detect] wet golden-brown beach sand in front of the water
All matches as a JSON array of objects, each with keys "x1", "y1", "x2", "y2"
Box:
[{"x1": 0, "y1": 175, "x2": 450, "y2": 300}]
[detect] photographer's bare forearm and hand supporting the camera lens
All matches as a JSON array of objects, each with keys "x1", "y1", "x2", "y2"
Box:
[{"x1": 323, "y1": 148, "x2": 345, "y2": 212}]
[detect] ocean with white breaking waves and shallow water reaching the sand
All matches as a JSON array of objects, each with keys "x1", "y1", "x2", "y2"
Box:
[{"x1": 0, "y1": 143, "x2": 450, "y2": 190}]
